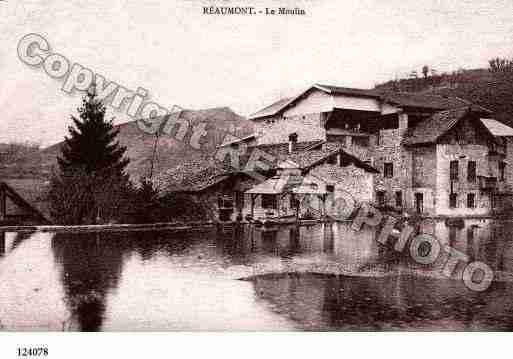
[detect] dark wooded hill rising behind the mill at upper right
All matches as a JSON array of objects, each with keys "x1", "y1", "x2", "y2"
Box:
[{"x1": 375, "y1": 69, "x2": 513, "y2": 127}]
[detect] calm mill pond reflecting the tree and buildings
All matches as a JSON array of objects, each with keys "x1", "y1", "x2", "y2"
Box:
[{"x1": 0, "y1": 220, "x2": 513, "y2": 331}]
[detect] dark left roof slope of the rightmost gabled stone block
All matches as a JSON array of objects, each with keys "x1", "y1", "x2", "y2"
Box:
[{"x1": 402, "y1": 106, "x2": 493, "y2": 146}]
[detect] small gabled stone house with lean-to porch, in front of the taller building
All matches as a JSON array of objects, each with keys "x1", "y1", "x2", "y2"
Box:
[{"x1": 245, "y1": 141, "x2": 378, "y2": 218}]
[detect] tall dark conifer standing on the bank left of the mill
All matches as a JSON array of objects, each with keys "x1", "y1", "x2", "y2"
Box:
[{"x1": 49, "y1": 86, "x2": 131, "y2": 224}]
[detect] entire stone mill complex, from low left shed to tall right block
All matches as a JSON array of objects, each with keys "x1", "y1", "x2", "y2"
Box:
[{"x1": 163, "y1": 84, "x2": 513, "y2": 221}]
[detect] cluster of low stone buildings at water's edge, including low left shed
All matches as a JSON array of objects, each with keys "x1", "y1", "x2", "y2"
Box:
[{"x1": 166, "y1": 135, "x2": 377, "y2": 221}]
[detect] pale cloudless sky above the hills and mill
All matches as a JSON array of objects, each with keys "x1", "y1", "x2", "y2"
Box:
[{"x1": 0, "y1": 0, "x2": 513, "y2": 146}]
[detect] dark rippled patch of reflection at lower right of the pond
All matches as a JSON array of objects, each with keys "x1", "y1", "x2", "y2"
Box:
[{"x1": 245, "y1": 273, "x2": 513, "y2": 330}]
